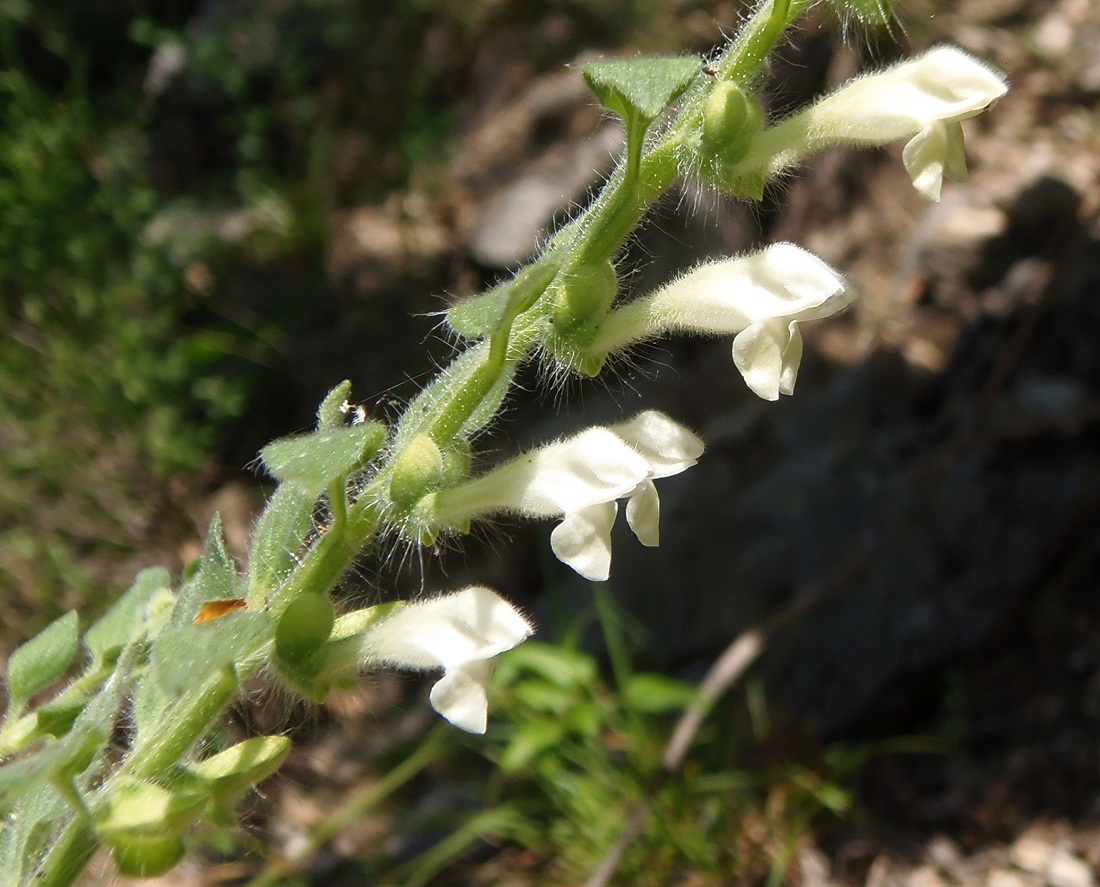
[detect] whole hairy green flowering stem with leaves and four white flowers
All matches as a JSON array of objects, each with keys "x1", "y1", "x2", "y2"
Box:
[{"x1": 0, "y1": 0, "x2": 1007, "y2": 887}]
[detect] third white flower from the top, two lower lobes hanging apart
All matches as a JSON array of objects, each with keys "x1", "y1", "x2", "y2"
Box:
[{"x1": 424, "y1": 410, "x2": 703, "y2": 582}]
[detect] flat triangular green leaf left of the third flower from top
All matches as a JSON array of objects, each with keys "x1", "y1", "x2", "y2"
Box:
[{"x1": 260, "y1": 421, "x2": 389, "y2": 496}]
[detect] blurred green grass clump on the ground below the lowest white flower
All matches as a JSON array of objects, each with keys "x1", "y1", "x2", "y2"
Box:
[{"x1": 459, "y1": 625, "x2": 866, "y2": 887}]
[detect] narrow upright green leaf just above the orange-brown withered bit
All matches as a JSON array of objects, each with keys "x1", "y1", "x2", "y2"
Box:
[{"x1": 249, "y1": 483, "x2": 317, "y2": 600}]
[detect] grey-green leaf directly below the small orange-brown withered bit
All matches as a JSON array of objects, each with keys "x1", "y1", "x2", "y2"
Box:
[{"x1": 153, "y1": 610, "x2": 272, "y2": 699}]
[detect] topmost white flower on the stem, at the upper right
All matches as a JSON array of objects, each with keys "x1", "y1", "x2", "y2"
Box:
[{"x1": 743, "y1": 46, "x2": 1009, "y2": 200}]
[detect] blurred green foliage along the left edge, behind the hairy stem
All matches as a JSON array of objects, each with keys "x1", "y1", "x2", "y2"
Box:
[{"x1": 0, "y1": 15, "x2": 232, "y2": 628}]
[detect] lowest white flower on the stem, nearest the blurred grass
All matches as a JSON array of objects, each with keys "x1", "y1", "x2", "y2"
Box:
[{"x1": 363, "y1": 585, "x2": 532, "y2": 733}]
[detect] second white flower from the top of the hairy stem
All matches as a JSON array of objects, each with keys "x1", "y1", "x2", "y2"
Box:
[{"x1": 592, "y1": 243, "x2": 856, "y2": 401}]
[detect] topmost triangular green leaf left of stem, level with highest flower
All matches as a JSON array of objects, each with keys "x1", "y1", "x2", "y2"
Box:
[{"x1": 582, "y1": 56, "x2": 702, "y2": 124}]
